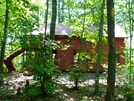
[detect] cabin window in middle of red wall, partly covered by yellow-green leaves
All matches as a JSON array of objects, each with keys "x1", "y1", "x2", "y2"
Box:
[{"x1": 73, "y1": 50, "x2": 88, "y2": 63}]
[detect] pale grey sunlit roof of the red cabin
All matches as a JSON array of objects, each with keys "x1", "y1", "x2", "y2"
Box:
[{"x1": 32, "y1": 23, "x2": 127, "y2": 38}]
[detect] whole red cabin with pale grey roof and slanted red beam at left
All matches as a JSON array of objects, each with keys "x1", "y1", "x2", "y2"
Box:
[{"x1": 4, "y1": 24, "x2": 127, "y2": 72}]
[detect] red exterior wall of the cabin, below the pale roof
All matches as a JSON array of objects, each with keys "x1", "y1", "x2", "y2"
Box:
[{"x1": 55, "y1": 36, "x2": 125, "y2": 72}]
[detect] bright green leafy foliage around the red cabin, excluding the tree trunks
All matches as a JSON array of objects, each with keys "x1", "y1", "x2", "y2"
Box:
[{"x1": 0, "y1": 0, "x2": 134, "y2": 100}]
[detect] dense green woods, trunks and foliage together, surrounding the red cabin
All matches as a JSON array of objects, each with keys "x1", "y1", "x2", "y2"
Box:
[{"x1": 0, "y1": 0, "x2": 134, "y2": 101}]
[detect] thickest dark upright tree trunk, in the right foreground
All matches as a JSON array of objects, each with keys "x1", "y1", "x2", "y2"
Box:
[{"x1": 105, "y1": 0, "x2": 116, "y2": 101}]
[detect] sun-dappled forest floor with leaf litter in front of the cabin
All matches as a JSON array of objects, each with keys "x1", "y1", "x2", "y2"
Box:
[{"x1": 0, "y1": 72, "x2": 130, "y2": 101}]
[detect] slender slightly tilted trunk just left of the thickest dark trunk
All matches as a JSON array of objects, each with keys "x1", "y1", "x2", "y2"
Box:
[{"x1": 94, "y1": 0, "x2": 105, "y2": 93}]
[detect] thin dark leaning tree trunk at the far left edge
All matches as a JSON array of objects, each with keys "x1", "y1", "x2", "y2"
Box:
[{"x1": 0, "y1": 0, "x2": 9, "y2": 85}]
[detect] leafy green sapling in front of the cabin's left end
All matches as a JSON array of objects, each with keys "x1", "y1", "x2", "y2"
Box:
[{"x1": 23, "y1": 35, "x2": 59, "y2": 96}]
